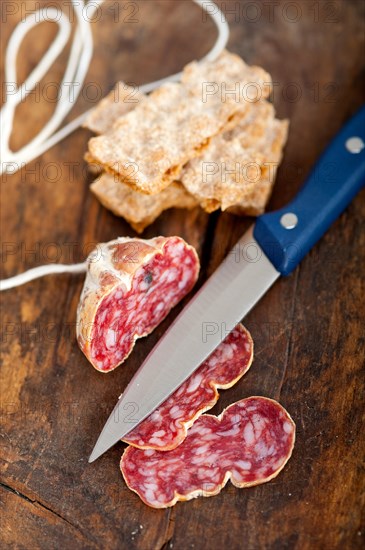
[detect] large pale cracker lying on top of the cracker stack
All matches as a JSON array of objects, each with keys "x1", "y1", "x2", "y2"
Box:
[{"x1": 89, "y1": 52, "x2": 270, "y2": 194}]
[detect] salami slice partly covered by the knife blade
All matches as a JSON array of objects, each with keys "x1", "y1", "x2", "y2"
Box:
[{"x1": 123, "y1": 325, "x2": 253, "y2": 451}]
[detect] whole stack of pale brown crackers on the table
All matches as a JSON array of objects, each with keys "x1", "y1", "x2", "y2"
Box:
[{"x1": 84, "y1": 51, "x2": 288, "y2": 233}]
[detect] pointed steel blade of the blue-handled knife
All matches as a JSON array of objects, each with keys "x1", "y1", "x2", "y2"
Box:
[{"x1": 89, "y1": 228, "x2": 280, "y2": 462}]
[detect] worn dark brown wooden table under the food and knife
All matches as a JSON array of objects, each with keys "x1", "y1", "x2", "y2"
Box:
[{"x1": 1, "y1": 0, "x2": 365, "y2": 550}]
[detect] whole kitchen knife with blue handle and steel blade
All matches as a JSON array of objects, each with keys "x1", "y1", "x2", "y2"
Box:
[{"x1": 89, "y1": 106, "x2": 365, "y2": 462}]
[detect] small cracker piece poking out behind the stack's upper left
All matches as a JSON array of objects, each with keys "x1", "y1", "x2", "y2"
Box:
[{"x1": 83, "y1": 82, "x2": 146, "y2": 134}]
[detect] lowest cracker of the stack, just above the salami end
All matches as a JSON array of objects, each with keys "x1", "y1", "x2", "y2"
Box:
[{"x1": 90, "y1": 174, "x2": 197, "y2": 233}]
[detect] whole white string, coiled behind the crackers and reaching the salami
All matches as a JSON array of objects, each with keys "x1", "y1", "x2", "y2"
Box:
[{"x1": 0, "y1": 0, "x2": 229, "y2": 291}]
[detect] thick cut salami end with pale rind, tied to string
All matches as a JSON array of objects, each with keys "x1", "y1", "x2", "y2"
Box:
[{"x1": 76, "y1": 237, "x2": 200, "y2": 372}]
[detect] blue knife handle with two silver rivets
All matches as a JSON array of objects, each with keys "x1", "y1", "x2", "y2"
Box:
[{"x1": 254, "y1": 107, "x2": 365, "y2": 275}]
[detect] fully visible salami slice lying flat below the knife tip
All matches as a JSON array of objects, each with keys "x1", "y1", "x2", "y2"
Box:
[{"x1": 120, "y1": 397, "x2": 295, "y2": 508}]
